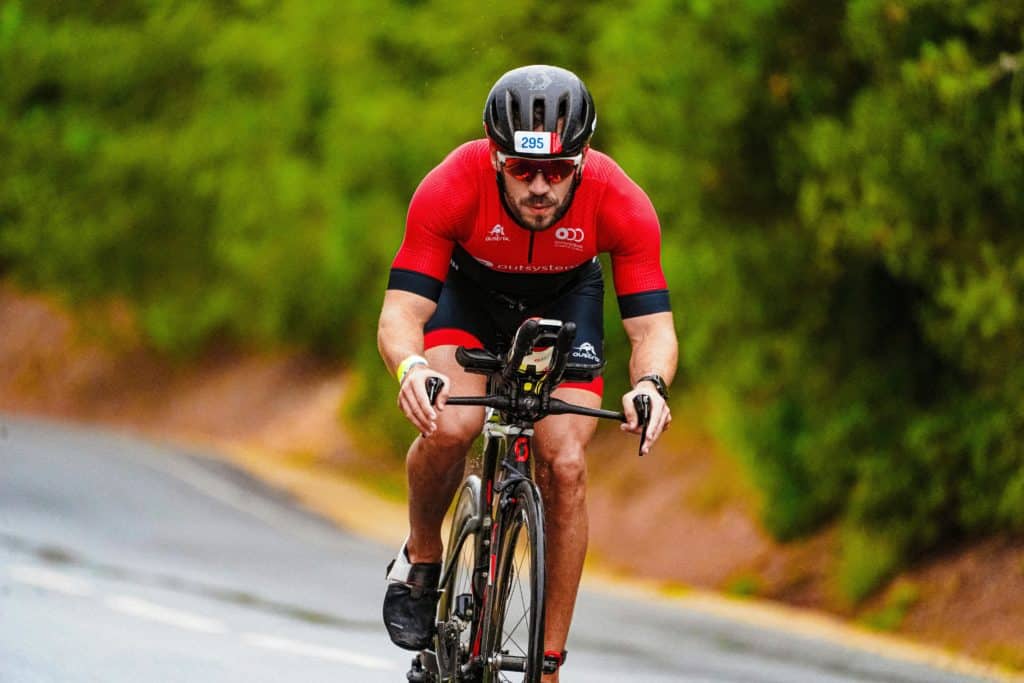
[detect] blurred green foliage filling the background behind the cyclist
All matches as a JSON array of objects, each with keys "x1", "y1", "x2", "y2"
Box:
[{"x1": 6, "y1": 0, "x2": 1024, "y2": 598}]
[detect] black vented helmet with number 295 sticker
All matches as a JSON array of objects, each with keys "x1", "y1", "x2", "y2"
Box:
[{"x1": 483, "y1": 65, "x2": 597, "y2": 158}]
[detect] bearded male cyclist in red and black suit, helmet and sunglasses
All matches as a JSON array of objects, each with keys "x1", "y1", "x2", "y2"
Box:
[{"x1": 378, "y1": 65, "x2": 677, "y2": 682}]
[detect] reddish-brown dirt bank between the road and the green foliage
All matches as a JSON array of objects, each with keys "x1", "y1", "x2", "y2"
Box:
[{"x1": 0, "y1": 286, "x2": 1024, "y2": 678}]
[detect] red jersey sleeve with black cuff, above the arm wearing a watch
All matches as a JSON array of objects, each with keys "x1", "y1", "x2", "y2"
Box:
[{"x1": 598, "y1": 166, "x2": 671, "y2": 318}]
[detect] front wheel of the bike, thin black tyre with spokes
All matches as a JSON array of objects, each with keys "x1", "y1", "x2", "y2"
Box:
[{"x1": 483, "y1": 480, "x2": 545, "y2": 683}]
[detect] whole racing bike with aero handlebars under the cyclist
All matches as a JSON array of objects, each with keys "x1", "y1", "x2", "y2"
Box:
[{"x1": 407, "y1": 318, "x2": 650, "y2": 683}]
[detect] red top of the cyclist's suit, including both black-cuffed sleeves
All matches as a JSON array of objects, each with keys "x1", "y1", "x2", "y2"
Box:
[{"x1": 388, "y1": 139, "x2": 669, "y2": 317}]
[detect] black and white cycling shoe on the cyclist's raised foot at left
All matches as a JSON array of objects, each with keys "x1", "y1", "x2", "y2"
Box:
[{"x1": 384, "y1": 545, "x2": 441, "y2": 650}]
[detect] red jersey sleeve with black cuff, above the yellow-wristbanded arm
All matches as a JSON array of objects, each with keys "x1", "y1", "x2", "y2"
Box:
[{"x1": 387, "y1": 145, "x2": 478, "y2": 301}]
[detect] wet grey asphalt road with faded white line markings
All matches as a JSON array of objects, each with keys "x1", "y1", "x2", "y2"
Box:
[{"x1": 0, "y1": 416, "x2": 985, "y2": 683}]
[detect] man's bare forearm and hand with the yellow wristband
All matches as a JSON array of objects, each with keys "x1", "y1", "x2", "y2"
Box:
[{"x1": 377, "y1": 289, "x2": 450, "y2": 436}]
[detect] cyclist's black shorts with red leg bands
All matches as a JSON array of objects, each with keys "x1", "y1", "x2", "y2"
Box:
[{"x1": 424, "y1": 254, "x2": 604, "y2": 396}]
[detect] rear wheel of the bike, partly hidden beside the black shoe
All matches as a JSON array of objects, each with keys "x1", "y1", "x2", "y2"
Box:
[{"x1": 434, "y1": 475, "x2": 482, "y2": 683}]
